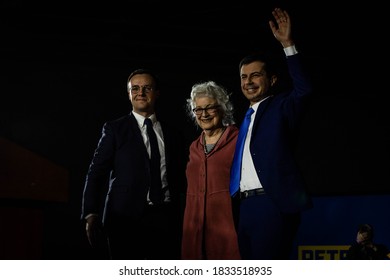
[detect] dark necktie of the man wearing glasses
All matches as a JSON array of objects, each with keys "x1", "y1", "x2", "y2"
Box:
[{"x1": 145, "y1": 118, "x2": 162, "y2": 204}]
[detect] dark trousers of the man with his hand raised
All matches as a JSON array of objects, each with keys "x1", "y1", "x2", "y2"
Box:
[{"x1": 238, "y1": 194, "x2": 300, "y2": 260}]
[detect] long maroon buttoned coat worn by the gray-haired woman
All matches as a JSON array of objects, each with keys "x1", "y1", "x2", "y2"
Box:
[{"x1": 182, "y1": 126, "x2": 240, "y2": 260}]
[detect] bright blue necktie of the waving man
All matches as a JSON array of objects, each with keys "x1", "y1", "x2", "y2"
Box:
[{"x1": 230, "y1": 108, "x2": 254, "y2": 196}]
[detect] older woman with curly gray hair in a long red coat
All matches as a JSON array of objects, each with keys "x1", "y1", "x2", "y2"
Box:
[{"x1": 182, "y1": 81, "x2": 240, "y2": 260}]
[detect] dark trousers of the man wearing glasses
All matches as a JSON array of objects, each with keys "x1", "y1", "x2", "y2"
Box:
[{"x1": 107, "y1": 205, "x2": 181, "y2": 260}]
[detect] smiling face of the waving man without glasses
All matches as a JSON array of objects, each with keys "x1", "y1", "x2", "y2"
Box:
[{"x1": 240, "y1": 61, "x2": 276, "y2": 105}]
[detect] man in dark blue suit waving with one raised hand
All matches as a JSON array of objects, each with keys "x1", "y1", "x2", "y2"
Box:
[{"x1": 231, "y1": 8, "x2": 312, "y2": 259}]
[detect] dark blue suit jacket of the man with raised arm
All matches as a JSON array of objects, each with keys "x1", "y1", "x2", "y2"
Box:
[{"x1": 250, "y1": 54, "x2": 312, "y2": 212}]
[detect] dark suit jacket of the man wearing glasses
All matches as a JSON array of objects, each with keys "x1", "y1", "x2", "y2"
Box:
[{"x1": 81, "y1": 114, "x2": 185, "y2": 226}]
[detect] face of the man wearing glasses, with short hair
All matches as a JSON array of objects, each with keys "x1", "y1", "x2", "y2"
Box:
[{"x1": 128, "y1": 74, "x2": 160, "y2": 117}]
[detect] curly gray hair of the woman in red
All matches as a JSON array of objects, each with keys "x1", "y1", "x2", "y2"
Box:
[{"x1": 186, "y1": 81, "x2": 235, "y2": 126}]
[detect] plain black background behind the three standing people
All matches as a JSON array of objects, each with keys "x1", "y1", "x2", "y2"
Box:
[{"x1": 0, "y1": 0, "x2": 390, "y2": 259}]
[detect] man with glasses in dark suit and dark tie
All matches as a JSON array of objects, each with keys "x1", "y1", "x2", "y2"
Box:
[{"x1": 81, "y1": 69, "x2": 185, "y2": 260}]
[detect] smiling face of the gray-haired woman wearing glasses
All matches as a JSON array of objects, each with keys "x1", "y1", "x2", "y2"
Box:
[{"x1": 195, "y1": 96, "x2": 223, "y2": 131}]
